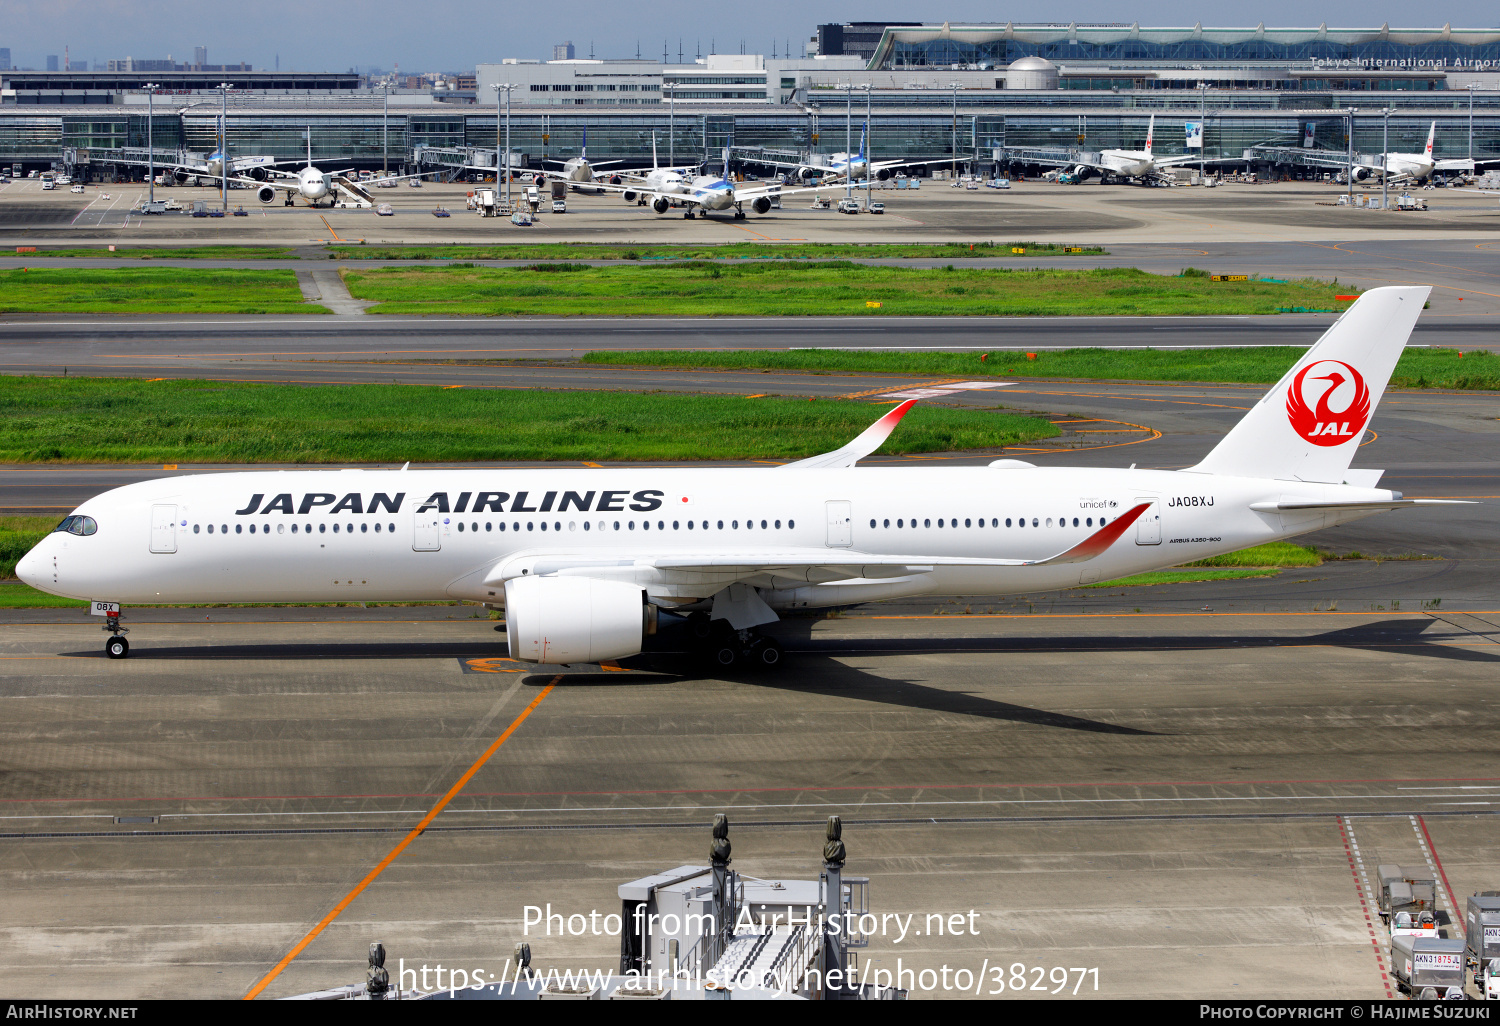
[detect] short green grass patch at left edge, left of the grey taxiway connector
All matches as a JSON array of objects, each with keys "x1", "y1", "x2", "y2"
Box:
[{"x1": 0, "y1": 267, "x2": 329, "y2": 314}]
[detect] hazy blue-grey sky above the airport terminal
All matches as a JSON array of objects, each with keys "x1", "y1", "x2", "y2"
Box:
[{"x1": 0, "y1": 0, "x2": 1500, "y2": 72}]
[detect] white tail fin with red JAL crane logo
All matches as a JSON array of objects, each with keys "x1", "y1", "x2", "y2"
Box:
[{"x1": 1188, "y1": 285, "x2": 1433, "y2": 485}]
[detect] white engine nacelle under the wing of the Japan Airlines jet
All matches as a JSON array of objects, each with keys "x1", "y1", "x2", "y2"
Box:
[{"x1": 506, "y1": 578, "x2": 656, "y2": 663}]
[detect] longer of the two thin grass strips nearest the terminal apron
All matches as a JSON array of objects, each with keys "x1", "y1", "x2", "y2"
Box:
[{"x1": 329, "y1": 242, "x2": 1109, "y2": 260}]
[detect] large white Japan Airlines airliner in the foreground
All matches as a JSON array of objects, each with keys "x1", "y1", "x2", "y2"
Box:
[{"x1": 17, "y1": 287, "x2": 1464, "y2": 666}]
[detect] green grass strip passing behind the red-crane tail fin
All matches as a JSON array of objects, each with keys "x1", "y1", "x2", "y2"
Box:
[{"x1": 584, "y1": 346, "x2": 1500, "y2": 389}]
